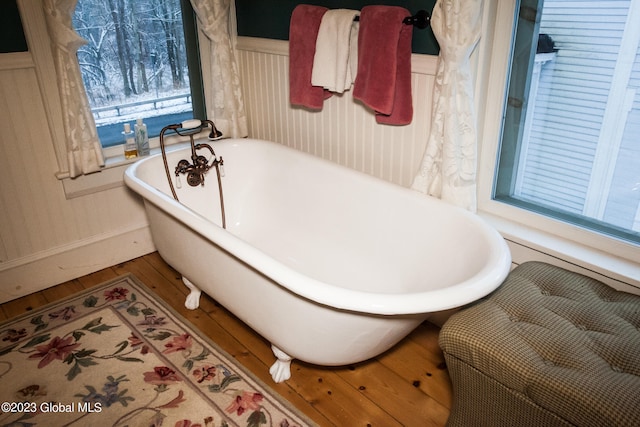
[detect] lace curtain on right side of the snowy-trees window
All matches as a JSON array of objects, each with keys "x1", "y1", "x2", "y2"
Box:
[{"x1": 191, "y1": 0, "x2": 248, "y2": 138}]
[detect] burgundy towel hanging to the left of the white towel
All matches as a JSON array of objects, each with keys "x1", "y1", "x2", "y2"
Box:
[{"x1": 289, "y1": 4, "x2": 331, "y2": 110}]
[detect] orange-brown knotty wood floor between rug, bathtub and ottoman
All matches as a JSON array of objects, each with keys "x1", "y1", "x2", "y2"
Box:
[{"x1": 0, "y1": 253, "x2": 451, "y2": 427}]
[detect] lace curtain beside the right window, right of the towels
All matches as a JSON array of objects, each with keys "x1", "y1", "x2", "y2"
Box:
[{"x1": 412, "y1": 0, "x2": 482, "y2": 212}]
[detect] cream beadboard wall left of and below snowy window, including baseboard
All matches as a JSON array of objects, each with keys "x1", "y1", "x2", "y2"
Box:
[{"x1": 0, "y1": 58, "x2": 154, "y2": 302}]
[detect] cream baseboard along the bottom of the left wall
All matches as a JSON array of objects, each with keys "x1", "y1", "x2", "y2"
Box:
[{"x1": 0, "y1": 224, "x2": 155, "y2": 303}]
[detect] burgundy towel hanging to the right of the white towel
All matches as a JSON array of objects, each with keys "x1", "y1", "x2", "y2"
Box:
[{"x1": 353, "y1": 6, "x2": 413, "y2": 125}]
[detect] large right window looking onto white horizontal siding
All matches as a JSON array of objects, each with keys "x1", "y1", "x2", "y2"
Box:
[{"x1": 493, "y1": 0, "x2": 640, "y2": 244}]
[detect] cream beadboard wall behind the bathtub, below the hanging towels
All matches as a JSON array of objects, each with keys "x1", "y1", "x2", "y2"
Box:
[{"x1": 237, "y1": 37, "x2": 437, "y2": 187}]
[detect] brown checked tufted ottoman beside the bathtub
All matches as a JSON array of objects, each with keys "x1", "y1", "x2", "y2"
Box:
[{"x1": 440, "y1": 262, "x2": 640, "y2": 427}]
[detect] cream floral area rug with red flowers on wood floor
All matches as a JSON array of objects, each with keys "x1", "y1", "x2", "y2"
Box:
[{"x1": 0, "y1": 276, "x2": 312, "y2": 427}]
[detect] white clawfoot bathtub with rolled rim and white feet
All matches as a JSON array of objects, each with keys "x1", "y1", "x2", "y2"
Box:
[{"x1": 125, "y1": 139, "x2": 511, "y2": 382}]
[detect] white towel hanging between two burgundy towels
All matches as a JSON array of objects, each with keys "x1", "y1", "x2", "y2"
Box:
[{"x1": 311, "y1": 9, "x2": 360, "y2": 93}]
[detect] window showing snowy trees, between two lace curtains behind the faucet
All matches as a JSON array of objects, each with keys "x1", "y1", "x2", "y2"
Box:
[{"x1": 73, "y1": 0, "x2": 205, "y2": 147}]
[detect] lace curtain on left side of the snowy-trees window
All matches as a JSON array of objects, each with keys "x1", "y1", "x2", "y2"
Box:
[{"x1": 44, "y1": 0, "x2": 104, "y2": 178}]
